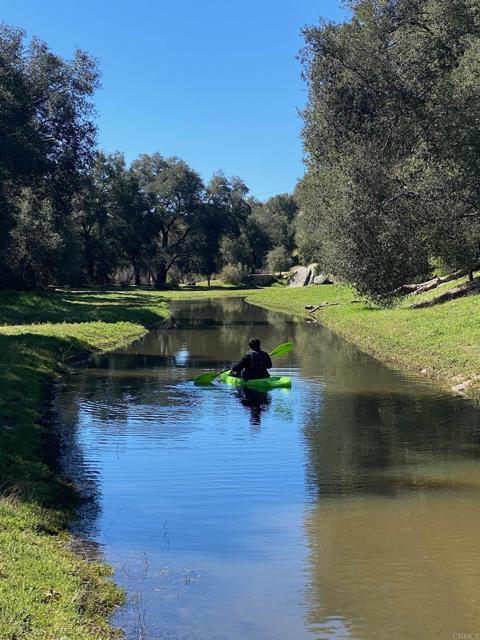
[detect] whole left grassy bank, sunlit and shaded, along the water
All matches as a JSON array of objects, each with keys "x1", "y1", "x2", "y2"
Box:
[{"x1": 0, "y1": 289, "x2": 255, "y2": 640}]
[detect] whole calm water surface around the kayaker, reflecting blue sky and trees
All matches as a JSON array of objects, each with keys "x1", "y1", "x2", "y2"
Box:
[{"x1": 58, "y1": 299, "x2": 480, "y2": 640}]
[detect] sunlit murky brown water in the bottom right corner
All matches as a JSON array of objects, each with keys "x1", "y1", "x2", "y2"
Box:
[{"x1": 305, "y1": 490, "x2": 480, "y2": 640}]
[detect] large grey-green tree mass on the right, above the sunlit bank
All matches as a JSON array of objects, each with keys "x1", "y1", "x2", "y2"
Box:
[{"x1": 296, "y1": 0, "x2": 480, "y2": 297}]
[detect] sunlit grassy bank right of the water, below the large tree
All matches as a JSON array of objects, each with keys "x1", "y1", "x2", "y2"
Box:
[{"x1": 248, "y1": 281, "x2": 480, "y2": 400}]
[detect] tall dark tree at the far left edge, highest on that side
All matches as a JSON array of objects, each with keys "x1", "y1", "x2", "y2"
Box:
[{"x1": 0, "y1": 26, "x2": 98, "y2": 286}]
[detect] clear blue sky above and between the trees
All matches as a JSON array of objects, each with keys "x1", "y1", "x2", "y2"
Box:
[{"x1": 0, "y1": 0, "x2": 345, "y2": 199}]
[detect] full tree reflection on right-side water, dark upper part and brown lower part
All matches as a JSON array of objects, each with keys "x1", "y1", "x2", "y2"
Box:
[{"x1": 300, "y1": 312, "x2": 480, "y2": 640}]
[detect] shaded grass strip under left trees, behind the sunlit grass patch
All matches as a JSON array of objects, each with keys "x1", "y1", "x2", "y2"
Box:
[{"x1": 0, "y1": 290, "x2": 172, "y2": 328}]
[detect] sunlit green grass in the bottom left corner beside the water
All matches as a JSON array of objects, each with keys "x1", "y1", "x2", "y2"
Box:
[{"x1": 0, "y1": 499, "x2": 122, "y2": 640}]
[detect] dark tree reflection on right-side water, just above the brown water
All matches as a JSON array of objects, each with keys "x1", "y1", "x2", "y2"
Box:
[{"x1": 304, "y1": 387, "x2": 480, "y2": 496}]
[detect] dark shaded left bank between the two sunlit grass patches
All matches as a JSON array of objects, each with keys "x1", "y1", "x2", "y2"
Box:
[{"x1": 0, "y1": 334, "x2": 94, "y2": 512}]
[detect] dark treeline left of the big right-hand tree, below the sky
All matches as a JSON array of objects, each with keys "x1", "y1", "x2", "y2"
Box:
[{"x1": 0, "y1": 26, "x2": 297, "y2": 288}]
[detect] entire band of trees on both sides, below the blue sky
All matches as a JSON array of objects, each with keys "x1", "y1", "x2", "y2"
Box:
[{"x1": 4, "y1": 0, "x2": 480, "y2": 300}]
